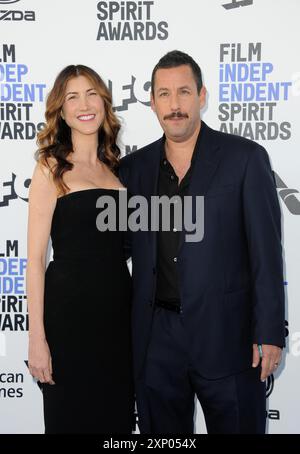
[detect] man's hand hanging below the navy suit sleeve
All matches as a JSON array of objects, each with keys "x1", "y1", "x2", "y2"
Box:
[{"x1": 252, "y1": 344, "x2": 282, "y2": 381}]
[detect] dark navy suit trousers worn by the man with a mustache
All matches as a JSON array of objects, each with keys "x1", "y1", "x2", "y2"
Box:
[{"x1": 142, "y1": 307, "x2": 266, "y2": 434}]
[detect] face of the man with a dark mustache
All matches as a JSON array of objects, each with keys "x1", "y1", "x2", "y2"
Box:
[{"x1": 151, "y1": 65, "x2": 206, "y2": 142}]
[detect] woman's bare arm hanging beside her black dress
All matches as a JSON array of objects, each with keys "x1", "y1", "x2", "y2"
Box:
[{"x1": 26, "y1": 163, "x2": 57, "y2": 383}]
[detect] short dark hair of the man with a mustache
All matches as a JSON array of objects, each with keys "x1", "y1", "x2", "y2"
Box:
[{"x1": 151, "y1": 50, "x2": 202, "y2": 95}]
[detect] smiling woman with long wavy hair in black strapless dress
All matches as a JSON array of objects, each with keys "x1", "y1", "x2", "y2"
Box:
[{"x1": 27, "y1": 65, "x2": 133, "y2": 433}]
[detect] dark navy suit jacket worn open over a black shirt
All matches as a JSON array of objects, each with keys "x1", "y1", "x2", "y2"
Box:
[{"x1": 119, "y1": 121, "x2": 285, "y2": 380}]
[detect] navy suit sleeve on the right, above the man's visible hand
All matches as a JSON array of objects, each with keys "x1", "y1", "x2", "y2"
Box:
[{"x1": 243, "y1": 146, "x2": 285, "y2": 347}]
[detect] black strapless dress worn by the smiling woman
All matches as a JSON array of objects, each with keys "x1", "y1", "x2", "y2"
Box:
[{"x1": 42, "y1": 188, "x2": 134, "y2": 434}]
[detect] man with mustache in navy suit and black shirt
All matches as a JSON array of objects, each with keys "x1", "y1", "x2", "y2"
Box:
[{"x1": 120, "y1": 51, "x2": 284, "y2": 434}]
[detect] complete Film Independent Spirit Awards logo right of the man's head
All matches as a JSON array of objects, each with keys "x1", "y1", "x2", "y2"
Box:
[{"x1": 218, "y1": 42, "x2": 293, "y2": 141}]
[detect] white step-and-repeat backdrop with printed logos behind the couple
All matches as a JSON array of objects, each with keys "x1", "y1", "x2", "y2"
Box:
[{"x1": 0, "y1": 0, "x2": 300, "y2": 434}]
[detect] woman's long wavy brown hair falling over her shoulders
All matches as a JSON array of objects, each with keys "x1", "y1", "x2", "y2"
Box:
[{"x1": 36, "y1": 65, "x2": 120, "y2": 194}]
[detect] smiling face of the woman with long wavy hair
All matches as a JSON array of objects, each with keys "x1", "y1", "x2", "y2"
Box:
[{"x1": 61, "y1": 76, "x2": 105, "y2": 135}]
